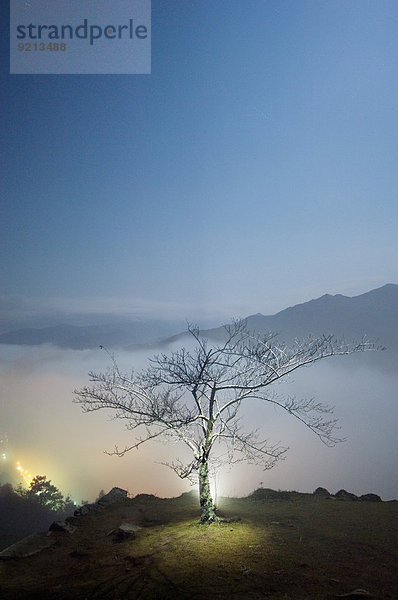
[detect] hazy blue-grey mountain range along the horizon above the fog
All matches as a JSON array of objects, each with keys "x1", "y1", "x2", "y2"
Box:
[{"x1": 0, "y1": 283, "x2": 398, "y2": 350}]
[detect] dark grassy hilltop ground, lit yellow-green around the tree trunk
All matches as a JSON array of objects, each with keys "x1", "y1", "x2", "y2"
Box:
[{"x1": 0, "y1": 495, "x2": 398, "y2": 600}]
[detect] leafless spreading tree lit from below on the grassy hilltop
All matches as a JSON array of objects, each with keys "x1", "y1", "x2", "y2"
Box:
[{"x1": 75, "y1": 321, "x2": 378, "y2": 522}]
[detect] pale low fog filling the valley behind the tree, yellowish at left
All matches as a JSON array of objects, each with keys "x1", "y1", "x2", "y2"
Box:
[{"x1": 0, "y1": 346, "x2": 398, "y2": 500}]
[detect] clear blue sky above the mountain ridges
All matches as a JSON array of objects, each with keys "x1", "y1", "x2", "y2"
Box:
[{"x1": 0, "y1": 0, "x2": 398, "y2": 318}]
